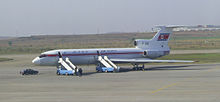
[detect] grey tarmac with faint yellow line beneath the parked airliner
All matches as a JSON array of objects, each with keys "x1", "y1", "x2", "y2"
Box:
[{"x1": 0, "y1": 55, "x2": 220, "y2": 102}]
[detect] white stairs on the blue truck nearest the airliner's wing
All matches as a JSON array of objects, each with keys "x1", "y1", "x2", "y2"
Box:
[{"x1": 98, "y1": 56, "x2": 120, "y2": 72}]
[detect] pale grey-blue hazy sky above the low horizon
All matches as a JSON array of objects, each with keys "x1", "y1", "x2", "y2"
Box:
[{"x1": 0, "y1": 0, "x2": 220, "y2": 36}]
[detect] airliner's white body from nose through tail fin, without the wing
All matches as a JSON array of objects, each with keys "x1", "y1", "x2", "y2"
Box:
[{"x1": 32, "y1": 26, "x2": 175, "y2": 65}]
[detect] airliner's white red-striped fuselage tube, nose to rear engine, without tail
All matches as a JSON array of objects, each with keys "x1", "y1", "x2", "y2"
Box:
[{"x1": 32, "y1": 48, "x2": 167, "y2": 66}]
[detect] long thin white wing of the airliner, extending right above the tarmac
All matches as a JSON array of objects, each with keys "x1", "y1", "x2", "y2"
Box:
[{"x1": 110, "y1": 58, "x2": 195, "y2": 63}]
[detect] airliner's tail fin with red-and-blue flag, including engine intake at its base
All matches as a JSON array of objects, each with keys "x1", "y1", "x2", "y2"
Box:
[{"x1": 135, "y1": 26, "x2": 183, "y2": 51}]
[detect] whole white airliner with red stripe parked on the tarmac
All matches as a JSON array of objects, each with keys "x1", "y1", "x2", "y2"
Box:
[{"x1": 32, "y1": 25, "x2": 194, "y2": 71}]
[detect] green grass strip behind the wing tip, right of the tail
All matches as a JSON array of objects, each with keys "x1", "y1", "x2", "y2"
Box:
[{"x1": 159, "y1": 53, "x2": 220, "y2": 63}]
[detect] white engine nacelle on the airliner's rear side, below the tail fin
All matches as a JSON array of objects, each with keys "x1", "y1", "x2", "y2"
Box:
[{"x1": 144, "y1": 50, "x2": 170, "y2": 58}]
